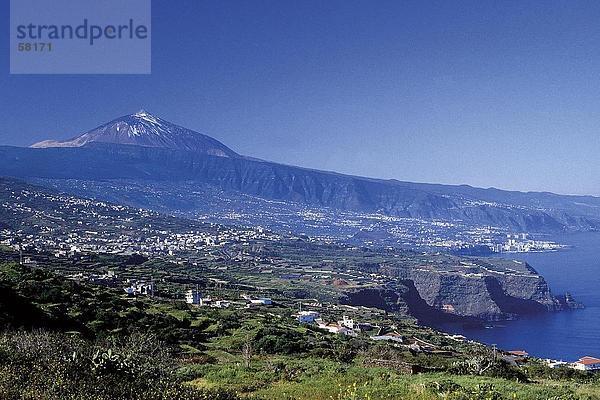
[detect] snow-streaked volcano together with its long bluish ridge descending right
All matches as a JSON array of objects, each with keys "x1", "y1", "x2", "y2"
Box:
[{"x1": 0, "y1": 112, "x2": 600, "y2": 232}]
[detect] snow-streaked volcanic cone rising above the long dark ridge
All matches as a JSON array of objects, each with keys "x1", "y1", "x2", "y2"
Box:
[{"x1": 31, "y1": 110, "x2": 238, "y2": 157}]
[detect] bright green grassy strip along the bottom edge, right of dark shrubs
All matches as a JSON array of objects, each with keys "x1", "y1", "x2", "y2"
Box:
[{"x1": 184, "y1": 358, "x2": 600, "y2": 400}]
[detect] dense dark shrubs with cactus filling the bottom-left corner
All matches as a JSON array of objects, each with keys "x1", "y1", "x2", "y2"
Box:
[{"x1": 0, "y1": 331, "x2": 235, "y2": 400}]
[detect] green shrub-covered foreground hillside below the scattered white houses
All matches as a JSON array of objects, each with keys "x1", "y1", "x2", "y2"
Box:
[{"x1": 0, "y1": 263, "x2": 600, "y2": 400}]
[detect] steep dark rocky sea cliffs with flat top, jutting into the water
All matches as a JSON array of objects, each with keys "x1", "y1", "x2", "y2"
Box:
[{"x1": 346, "y1": 258, "x2": 584, "y2": 322}]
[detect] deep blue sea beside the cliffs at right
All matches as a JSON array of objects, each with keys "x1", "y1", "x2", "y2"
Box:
[{"x1": 440, "y1": 233, "x2": 600, "y2": 361}]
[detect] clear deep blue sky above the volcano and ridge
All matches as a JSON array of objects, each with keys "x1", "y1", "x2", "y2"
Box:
[{"x1": 0, "y1": 0, "x2": 600, "y2": 195}]
